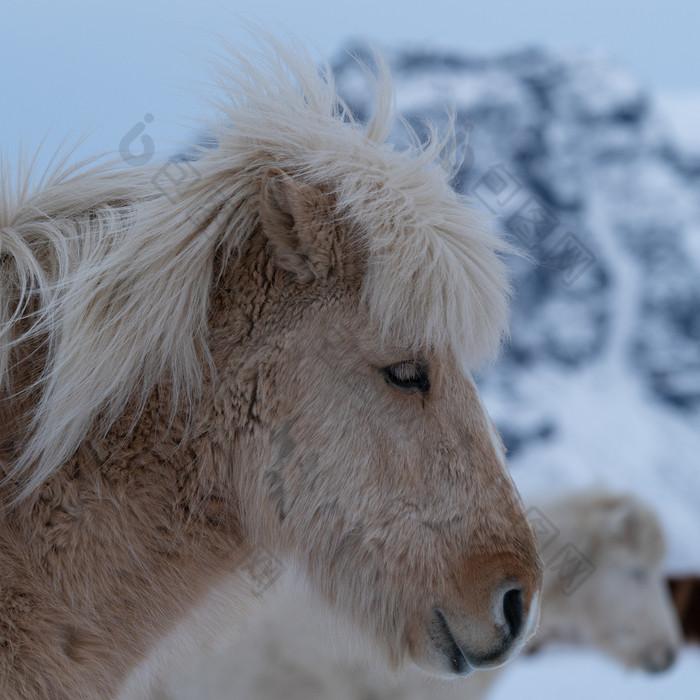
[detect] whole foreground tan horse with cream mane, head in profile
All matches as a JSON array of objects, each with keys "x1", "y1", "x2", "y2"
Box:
[{"x1": 0, "y1": 34, "x2": 542, "y2": 700}]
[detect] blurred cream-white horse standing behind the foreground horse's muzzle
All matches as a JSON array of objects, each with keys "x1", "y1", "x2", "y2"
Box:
[{"x1": 153, "y1": 490, "x2": 681, "y2": 700}]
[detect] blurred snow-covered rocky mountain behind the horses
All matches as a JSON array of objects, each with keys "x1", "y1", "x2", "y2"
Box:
[{"x1": 334, "y1": 46, "x2": 700, "y2": 571}]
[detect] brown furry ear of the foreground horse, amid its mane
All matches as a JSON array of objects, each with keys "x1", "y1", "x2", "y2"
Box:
[{"x1": 260, "y1": 168, "x2": 332, "y2": 284}]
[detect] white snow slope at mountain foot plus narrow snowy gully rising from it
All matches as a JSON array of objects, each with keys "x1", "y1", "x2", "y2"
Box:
[{"x1": 484, "y1": 168, "x2": 700, "y2": 573}]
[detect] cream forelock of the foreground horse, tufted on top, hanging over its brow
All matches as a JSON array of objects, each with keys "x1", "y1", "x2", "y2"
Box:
[{"x1": 205, "y1": 37, "x2": 510, "y2": 367}]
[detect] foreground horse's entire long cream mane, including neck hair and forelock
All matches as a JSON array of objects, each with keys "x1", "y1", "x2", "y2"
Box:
[{"x1": 0, "y1": 35, "x2": 508, "y2": 493}]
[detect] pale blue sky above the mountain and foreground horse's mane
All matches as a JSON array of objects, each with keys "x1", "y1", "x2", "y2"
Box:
[{"x1": 0, "y1": 0, "x2": 700, "y2": 167}]
